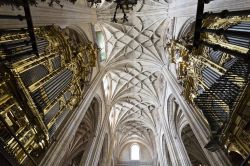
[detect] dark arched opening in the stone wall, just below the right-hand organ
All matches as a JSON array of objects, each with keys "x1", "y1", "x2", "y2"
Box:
[{"x1": 181, "y1": 125, "x2": 210, "y2": 166}]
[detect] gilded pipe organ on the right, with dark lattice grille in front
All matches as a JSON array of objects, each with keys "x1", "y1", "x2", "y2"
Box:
[{"x1": 168, "y1": 16, "x2": 250, "y2": 157}]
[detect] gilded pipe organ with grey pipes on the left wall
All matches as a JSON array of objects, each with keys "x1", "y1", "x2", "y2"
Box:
[{"x1": 0, "y1": 26, "x2": 97, "y2": 165}]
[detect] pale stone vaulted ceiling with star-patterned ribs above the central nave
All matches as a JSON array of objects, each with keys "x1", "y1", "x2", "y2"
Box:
[{"x1": 98, "y1": 0, "x2": 170, "y2": 160}]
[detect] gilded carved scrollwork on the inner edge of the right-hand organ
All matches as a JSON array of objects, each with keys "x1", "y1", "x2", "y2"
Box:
[{"x1": 168, "y1": 41, "x2": 205, "y2": 103}]
